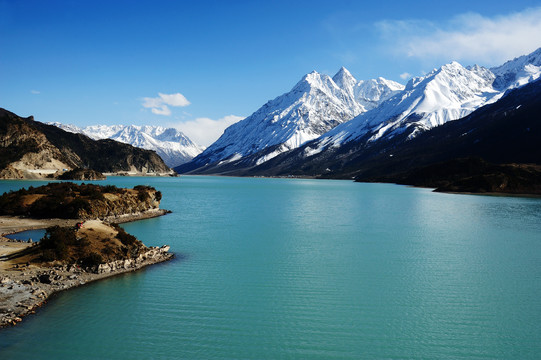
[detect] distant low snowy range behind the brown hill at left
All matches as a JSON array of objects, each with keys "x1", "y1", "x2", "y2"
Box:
[{"x1": 51, "y1": 123, "x2": 204, "y2": 167}]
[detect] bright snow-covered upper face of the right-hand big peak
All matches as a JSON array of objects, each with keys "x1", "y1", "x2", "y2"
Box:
[{"x1": 307, "y1": 62, "x2": 503, "y2": 155}]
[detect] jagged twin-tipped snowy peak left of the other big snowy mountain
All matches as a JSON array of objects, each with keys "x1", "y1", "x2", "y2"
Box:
[{"x1": 179, "y1": 68, "x2": 404, "y2": 169}]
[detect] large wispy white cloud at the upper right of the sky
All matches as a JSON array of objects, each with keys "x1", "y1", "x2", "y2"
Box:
[{"x1": 376, "y1": 7, "x2": 541, "y2": 66}]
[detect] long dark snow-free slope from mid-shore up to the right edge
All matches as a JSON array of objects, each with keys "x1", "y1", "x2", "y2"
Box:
[{"x1": 249, "y1": 80, "x2": 541, "y2": 180}]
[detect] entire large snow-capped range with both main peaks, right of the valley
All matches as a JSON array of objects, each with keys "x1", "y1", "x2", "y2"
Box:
[{"x1": 176, "y1": 49, "x2": 541, "y2": 183}]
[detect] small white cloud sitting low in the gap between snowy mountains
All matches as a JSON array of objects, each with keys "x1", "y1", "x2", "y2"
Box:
[{"x1": 173, "y1": 115, "x2": 244, "y2": 146}]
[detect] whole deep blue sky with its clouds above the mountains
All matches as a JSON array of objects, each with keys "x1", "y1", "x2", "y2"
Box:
[{"x1": 0, "y1": 0, "x2": 541, "y2": 145}]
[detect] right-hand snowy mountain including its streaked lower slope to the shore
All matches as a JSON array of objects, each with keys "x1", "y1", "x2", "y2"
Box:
[{"x1": 242, "y1": 49, "x2": 541, "y2": 176}]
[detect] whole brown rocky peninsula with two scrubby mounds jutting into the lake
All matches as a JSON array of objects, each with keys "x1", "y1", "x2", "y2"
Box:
[{"x1": 0, "y1": 183, "x2": 174, "y2": 327}]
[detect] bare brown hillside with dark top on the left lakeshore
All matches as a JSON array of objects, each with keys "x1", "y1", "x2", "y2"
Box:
[{"x1": 0, "y1": 109, "x2": 172, "y2": 178}]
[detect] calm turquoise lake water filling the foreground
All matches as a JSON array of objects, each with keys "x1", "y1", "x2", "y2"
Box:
[{"x1": 0, "y1": 177, "x2": 541, "y2": 359}]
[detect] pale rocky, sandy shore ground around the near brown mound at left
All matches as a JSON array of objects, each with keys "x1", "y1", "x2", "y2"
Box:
[{"x1": 0, "y1": 209, "x2": 174, "y2": 328}]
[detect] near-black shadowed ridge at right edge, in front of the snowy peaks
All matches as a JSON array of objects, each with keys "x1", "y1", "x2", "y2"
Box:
[{"x1": 352, "y1": 77, "x2": 541, "y2": 179}]
